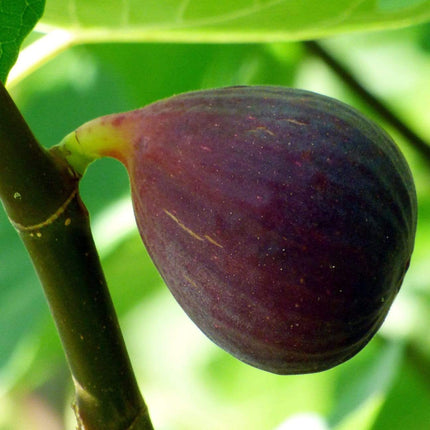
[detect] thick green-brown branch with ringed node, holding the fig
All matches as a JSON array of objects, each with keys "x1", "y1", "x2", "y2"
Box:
[{"x1": 0, "y1": 84, "x2": 153, "y2": 430}]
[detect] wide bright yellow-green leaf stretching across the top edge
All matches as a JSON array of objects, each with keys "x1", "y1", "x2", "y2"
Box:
[{"x1": 43, "y1": 0, "x2": 430, "y2": 42}]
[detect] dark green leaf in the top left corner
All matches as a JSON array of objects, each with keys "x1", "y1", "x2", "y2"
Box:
[{"x1": 0, "y1": 0, "x2": 45, "y2": 83}]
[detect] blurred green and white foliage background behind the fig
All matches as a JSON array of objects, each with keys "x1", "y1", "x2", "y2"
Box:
[{"x1": 0, "y1": 2, "x2": 430, "y2": 430}]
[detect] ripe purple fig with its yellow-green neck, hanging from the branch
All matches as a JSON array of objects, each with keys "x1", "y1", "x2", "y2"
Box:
[{"x1": 56, "y1": 86, "x2": 417, "y2": 374}]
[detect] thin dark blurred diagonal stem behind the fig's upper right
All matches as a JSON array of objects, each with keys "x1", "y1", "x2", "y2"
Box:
[{"x1": 303, "y1": 41, "x2": 430, "y2": 163}]
